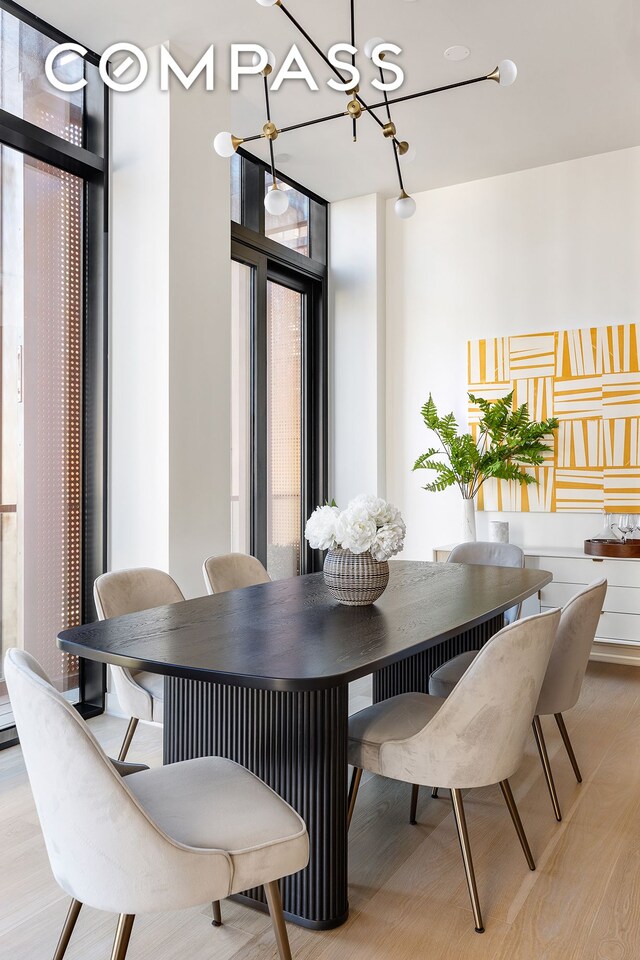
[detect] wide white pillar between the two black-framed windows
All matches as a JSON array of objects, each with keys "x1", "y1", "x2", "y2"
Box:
[{"x1": 109, "y1": 46, "x2": 231, "y2": 596}]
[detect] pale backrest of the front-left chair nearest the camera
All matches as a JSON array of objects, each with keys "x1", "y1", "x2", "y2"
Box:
[{"x1": 4, "y1": 649, "x2": 230, "y2": 913}]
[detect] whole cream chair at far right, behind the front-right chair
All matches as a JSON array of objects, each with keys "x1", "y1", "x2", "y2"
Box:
[{"x1": 429, "y1": 580, "x2": 607, "y2": 821}]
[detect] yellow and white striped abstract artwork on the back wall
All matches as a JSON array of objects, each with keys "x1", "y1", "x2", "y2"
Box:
[{"x1": 468, "y1": 323, "x2": 640, "y2": 513}]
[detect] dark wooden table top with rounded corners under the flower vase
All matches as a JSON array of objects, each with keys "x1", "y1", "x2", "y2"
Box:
[{"x1": 58, "y1": 560, "x2": 552, "y2": 690}]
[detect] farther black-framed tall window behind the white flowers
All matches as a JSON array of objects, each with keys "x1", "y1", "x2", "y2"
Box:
[{"x1": 231, "y1": 154, "x2": 327, "y2": 579}]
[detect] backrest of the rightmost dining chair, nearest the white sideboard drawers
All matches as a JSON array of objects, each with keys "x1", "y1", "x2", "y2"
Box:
[{"x1": 536, "y1": 580, "x2": 607, "y2": 716}]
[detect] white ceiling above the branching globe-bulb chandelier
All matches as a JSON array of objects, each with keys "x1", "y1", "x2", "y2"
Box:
[{"x1": 25, "y1": 0, "x2": 640, "y2": 200}]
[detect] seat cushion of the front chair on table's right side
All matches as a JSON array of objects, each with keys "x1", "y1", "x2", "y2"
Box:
[{"x1": 347, "y1": 693, "x2": 444, "y2": 773}]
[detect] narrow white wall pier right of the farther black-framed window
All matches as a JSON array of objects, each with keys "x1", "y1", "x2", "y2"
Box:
[{"x1": 329, "y1": 194, "x2": 386, "y2": 506}]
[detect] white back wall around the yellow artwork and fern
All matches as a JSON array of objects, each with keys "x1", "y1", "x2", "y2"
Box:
[{"x1": 387, "y1": 147, "x2": 640, "y2": 559}]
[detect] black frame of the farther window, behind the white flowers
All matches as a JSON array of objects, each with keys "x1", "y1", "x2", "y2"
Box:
[{"x1": 231, "y1": 150, "x2": 329, "y2": 573}]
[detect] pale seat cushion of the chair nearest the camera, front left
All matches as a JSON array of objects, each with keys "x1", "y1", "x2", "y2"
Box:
[{"x1": 125, "y1": 757, "x2": 309, "y2": 893}]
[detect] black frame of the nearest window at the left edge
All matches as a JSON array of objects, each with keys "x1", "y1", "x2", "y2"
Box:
[{"x1": 0, "y1": 0, "x2": 109, "y2": 749}]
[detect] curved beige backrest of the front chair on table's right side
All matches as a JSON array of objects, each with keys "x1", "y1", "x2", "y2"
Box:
[{"x1": 380, "y1": 610, "x2": 560, "y2": 789}]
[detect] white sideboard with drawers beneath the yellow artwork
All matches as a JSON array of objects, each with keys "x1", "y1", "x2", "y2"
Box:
[{"x1": 433, "y1": 545, "x2": 640, "y2": 666}]
